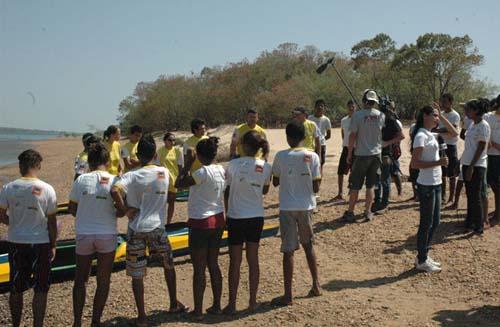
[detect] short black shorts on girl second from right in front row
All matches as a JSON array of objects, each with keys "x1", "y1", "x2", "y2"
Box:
[{"x1": 227, "y1": 217, "x2": 264, "y2": 245}]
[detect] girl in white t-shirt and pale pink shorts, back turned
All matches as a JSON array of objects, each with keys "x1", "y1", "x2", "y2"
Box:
[{"x1": 69, "y1": 143, "x2": 118, "y2": 326}]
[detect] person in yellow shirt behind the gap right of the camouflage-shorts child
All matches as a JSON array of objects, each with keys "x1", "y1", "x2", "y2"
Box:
[{"x1": 156, "y1": 133, "x2": 184, "y2": 225}]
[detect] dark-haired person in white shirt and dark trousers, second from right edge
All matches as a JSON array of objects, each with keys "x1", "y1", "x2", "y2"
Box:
[{"x1": 460, "y1": 99, "x2": 490, "y2": 234}]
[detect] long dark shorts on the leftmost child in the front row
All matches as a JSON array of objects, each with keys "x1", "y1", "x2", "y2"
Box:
[{"x1": 9, "y1": 243, "x2": 52, "y2": 293}]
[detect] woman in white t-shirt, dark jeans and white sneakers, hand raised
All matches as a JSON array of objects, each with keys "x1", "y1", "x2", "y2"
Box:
[{"x1": 410, "y1": 103, "x2": 458, "y2": 272}]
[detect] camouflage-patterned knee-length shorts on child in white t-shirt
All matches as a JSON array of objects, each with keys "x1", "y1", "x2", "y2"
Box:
[{"x1": 127, "y1": 228, "x2": 174, "y2": 278}]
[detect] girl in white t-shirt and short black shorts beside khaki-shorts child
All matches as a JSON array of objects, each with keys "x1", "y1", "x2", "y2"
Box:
[{"x1": 224, "y1": 131, "x2": 271, "y2": 314}]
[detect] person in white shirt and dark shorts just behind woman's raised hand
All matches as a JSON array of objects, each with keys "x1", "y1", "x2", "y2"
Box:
[{"x1": 439, "y1": 93, "x2": 460, "y2": 203}]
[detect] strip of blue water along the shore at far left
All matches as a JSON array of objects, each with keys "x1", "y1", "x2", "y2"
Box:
[{"x1": 0, "y1": 131, "x2": 59, "y2": 167}]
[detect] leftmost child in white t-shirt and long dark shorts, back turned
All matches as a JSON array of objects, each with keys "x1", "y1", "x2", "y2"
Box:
[{"x1": 0, "y1": 150, "x2": 57, "y2": 326}]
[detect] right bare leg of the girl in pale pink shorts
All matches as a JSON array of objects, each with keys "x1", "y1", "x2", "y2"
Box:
[{"x1": 92, "y1": 251, "x2": 115, "y2": 325}]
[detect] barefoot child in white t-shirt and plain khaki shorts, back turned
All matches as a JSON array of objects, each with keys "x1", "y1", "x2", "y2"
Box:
[{"x1": 272, "y1": 121, "x2": 321, "y2": 305}]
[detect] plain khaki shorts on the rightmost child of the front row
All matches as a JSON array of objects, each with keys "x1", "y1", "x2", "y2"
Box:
[{"x1": 280, "y1": 210, "x2": 313, "y2": 253}]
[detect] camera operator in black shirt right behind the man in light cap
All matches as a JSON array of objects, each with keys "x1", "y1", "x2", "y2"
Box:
[{"x1": 372, "y1": 97, "x2": 404, "y2": 213}]
